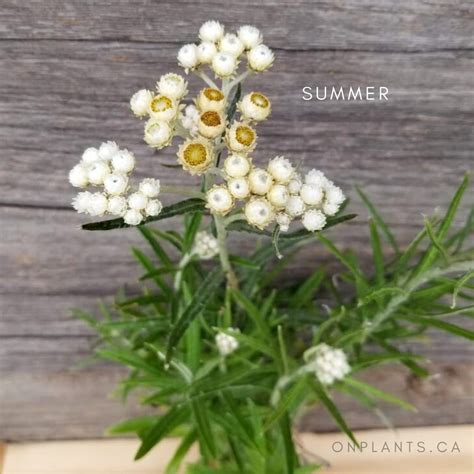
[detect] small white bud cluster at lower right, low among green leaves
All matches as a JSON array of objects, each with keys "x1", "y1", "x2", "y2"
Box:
[{"x1": 309, "y1": 343, "x2": 351, "y2": 385}]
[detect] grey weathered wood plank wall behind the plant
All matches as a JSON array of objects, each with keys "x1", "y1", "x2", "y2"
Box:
[{"x1": 0, "y1": 0, "x2": 474, "y2": 440}]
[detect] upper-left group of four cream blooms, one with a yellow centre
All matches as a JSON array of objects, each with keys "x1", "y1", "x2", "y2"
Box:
[{"x1": 130, "y1": 72, "x2": 188, "y2": 149}]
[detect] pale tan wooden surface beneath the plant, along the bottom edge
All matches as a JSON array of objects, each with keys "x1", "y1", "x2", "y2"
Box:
[{"x1": 3, "y1": 425, "x2": 474, "y2": 474}]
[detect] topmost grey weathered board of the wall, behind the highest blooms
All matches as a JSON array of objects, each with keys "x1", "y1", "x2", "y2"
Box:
[{"x1": 0, "y1": 0, "x2": 473, "y2": 51}]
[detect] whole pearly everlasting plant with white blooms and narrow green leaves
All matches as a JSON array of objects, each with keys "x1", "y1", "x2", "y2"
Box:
[{"x1": 69, "y1": 21, "x2": 474, "y2": 474}]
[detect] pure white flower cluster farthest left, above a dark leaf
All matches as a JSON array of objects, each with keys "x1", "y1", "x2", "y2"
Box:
[{"x1": 69, "y1": 142, "x2": 163, "y2": 225}]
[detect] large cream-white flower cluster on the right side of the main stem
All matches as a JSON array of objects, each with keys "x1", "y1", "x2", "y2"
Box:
[{"x1": 206, "y1": 150, "x2": 345, "y2": 232}]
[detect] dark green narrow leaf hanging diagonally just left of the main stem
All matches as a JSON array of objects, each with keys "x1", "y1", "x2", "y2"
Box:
[{"x1": 166, "y1": 267, "x2": 222, "y2": 361}]
